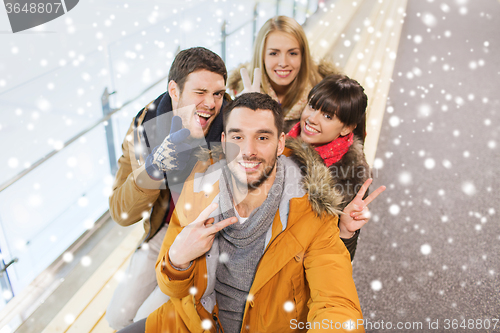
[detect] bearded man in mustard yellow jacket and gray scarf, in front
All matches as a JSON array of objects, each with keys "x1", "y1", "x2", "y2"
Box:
[{"x1": 120, "y1": 93, "x2": 364, "y2": 333}]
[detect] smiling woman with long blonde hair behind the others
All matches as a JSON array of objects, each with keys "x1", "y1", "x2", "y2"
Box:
[{"x1": 228, "y1": 16, "x2": 337, "y2": 130}]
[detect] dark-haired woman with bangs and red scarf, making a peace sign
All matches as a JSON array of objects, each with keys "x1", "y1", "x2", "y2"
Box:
[{"x1": 286, "y1": 75, "x2": 385, "y2": 260}]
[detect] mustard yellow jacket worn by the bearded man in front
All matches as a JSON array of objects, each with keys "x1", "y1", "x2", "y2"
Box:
[{"x1": 146, "y1": 154, "x2": 364, "y2": 333}]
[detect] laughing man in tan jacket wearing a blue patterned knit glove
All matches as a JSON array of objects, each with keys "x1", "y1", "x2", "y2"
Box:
[{"x1": 106, "y1": 47, "x2": 227, "y2": 329}]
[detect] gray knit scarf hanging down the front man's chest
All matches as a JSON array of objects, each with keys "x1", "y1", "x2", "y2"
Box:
[{"x1": 215, "y1": 156, "x2": 285, "y2": 333}]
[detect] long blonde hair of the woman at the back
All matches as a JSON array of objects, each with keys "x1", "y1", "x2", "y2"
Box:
[{"x1": 250, "y1": 16, "x2": 321, "y2": 115}]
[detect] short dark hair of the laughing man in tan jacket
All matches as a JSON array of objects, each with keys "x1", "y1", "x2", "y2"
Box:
[{"x1": 168, "y1": 47, "x2": 227, "y2": 92}]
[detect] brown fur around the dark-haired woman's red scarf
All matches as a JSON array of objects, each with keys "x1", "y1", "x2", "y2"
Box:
[{"x1": 286, "y1": 137, "x2": 370, "y2": 212}]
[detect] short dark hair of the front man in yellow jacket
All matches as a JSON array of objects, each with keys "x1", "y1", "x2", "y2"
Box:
[{"x1": 222, "y1": 93, "x2": 284, "y2": 137}]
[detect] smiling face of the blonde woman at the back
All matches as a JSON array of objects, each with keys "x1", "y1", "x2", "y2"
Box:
[{"x1": 264, "y1": 31, "x2": 302, "y2": 92}]
